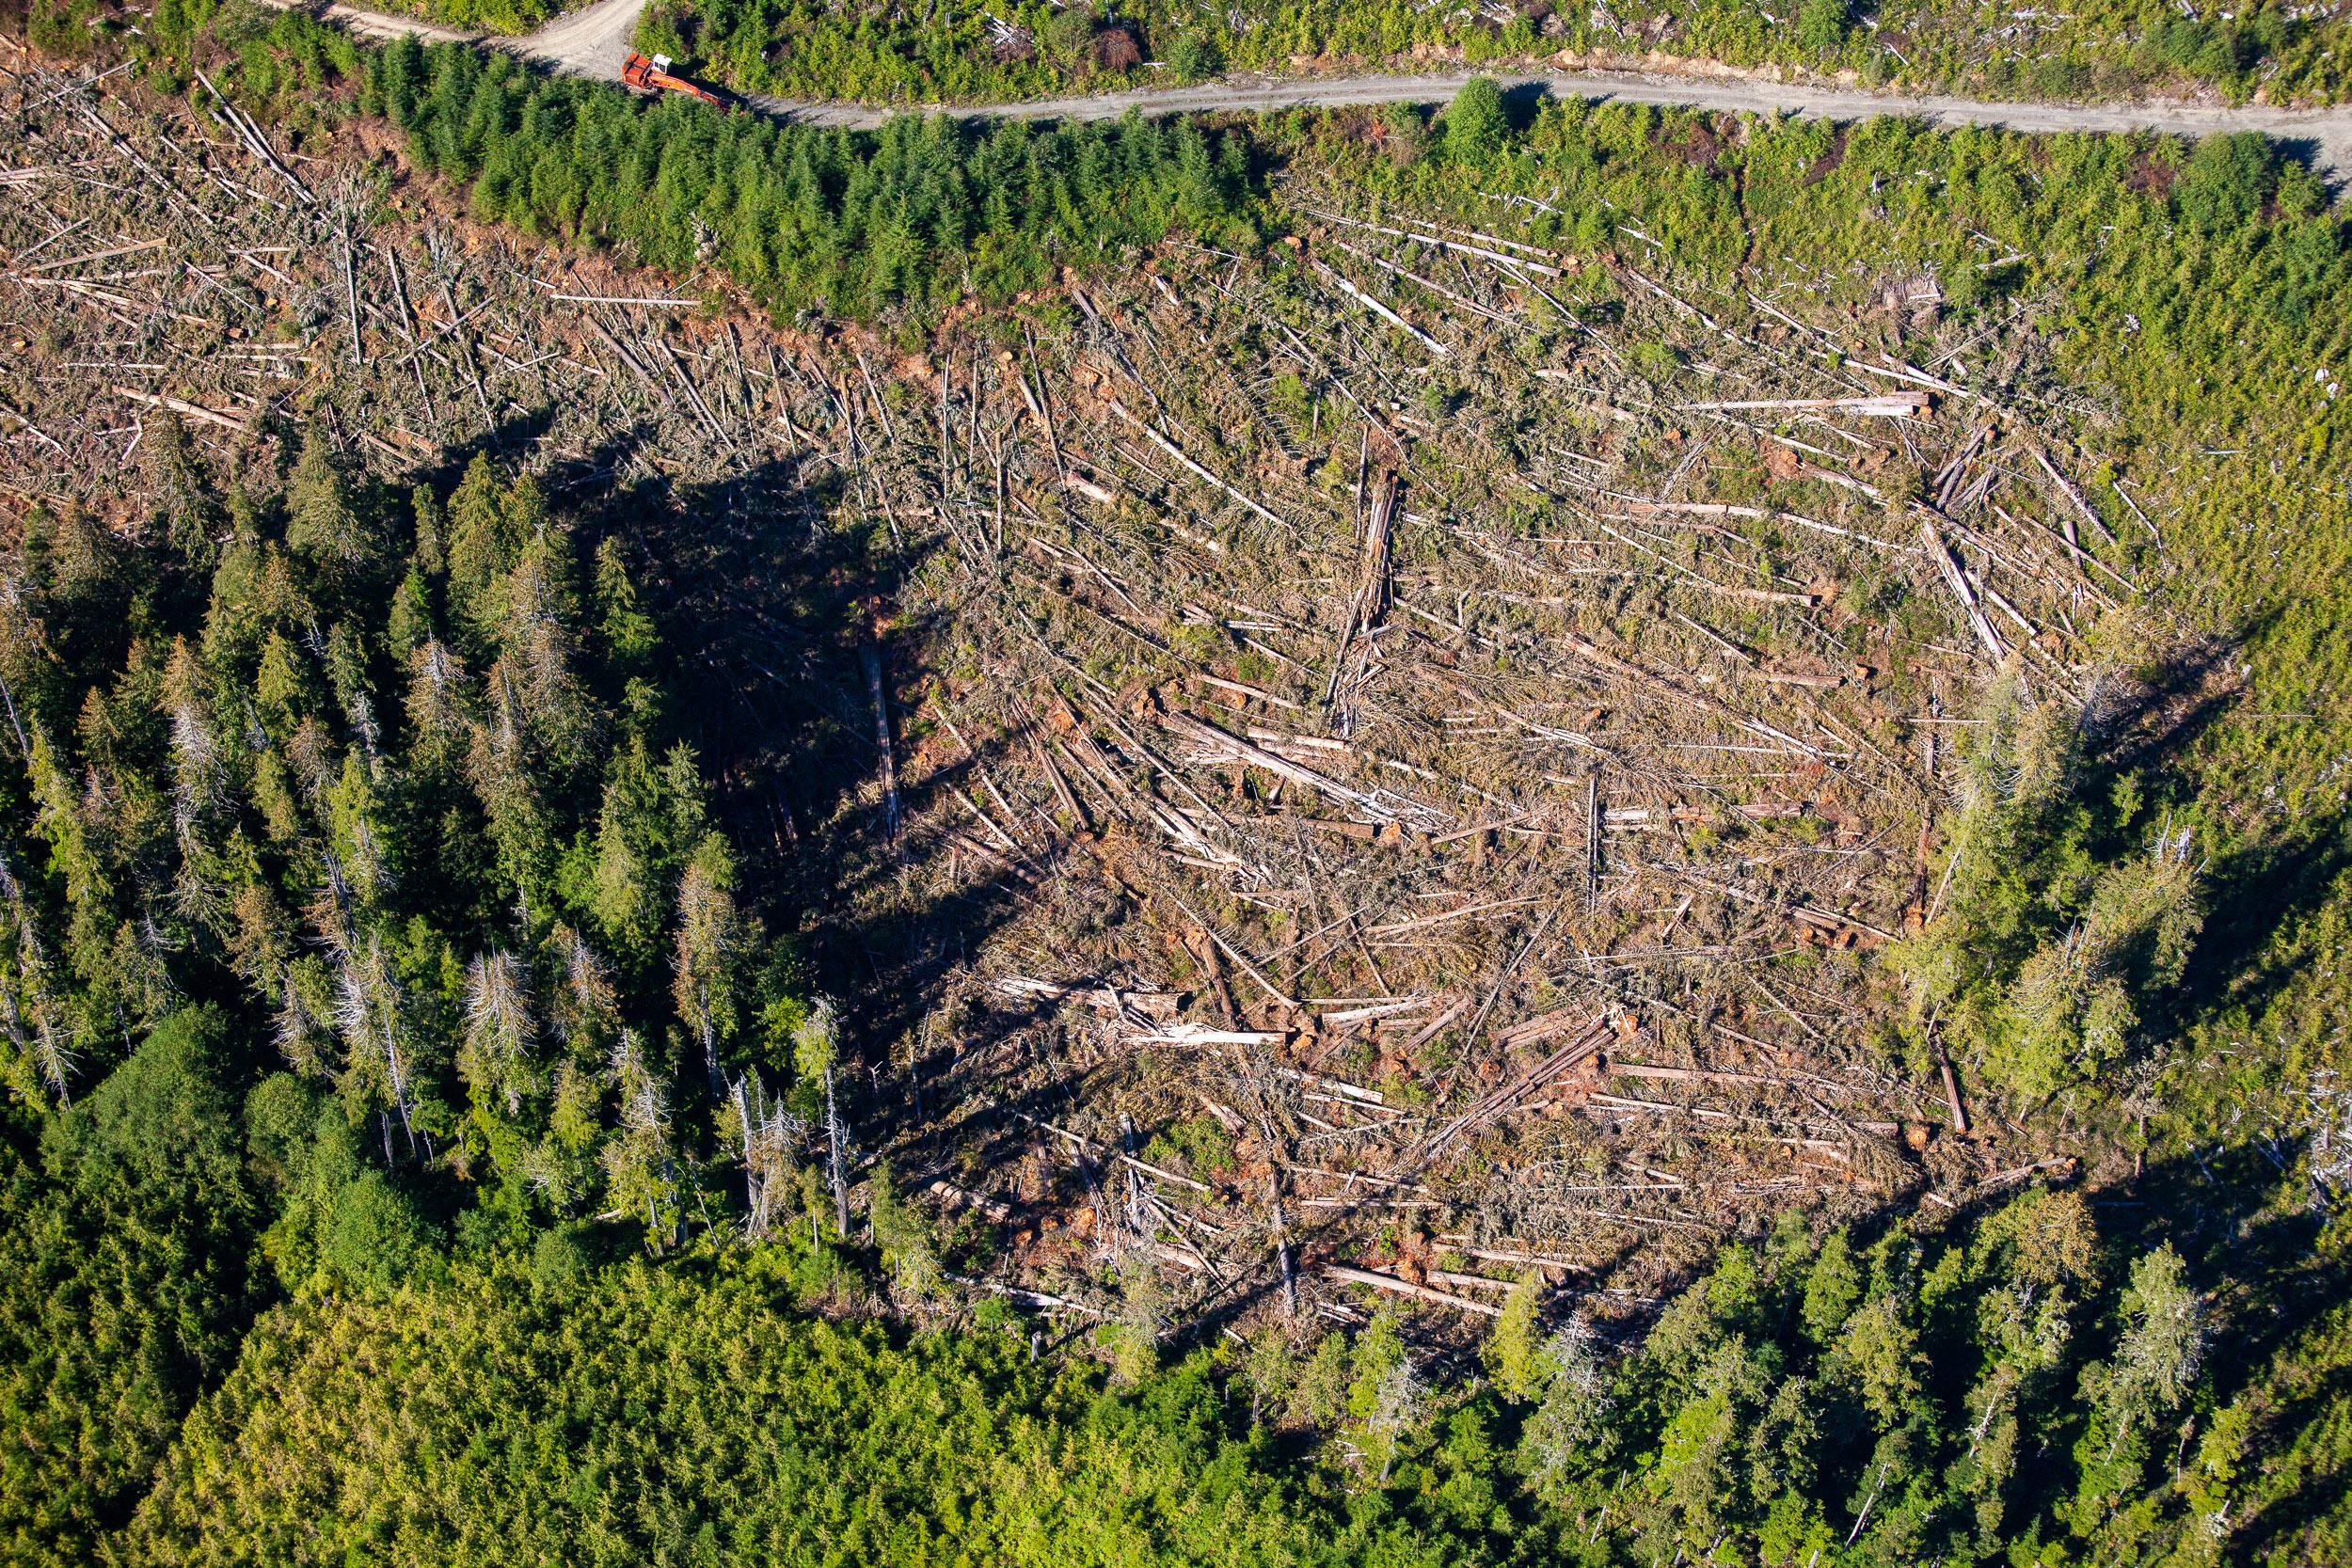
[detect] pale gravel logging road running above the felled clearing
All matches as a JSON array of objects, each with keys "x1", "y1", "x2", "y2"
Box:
[{"x1": 289, "y1": 0, "x2": 2352, "y2": 176}]
